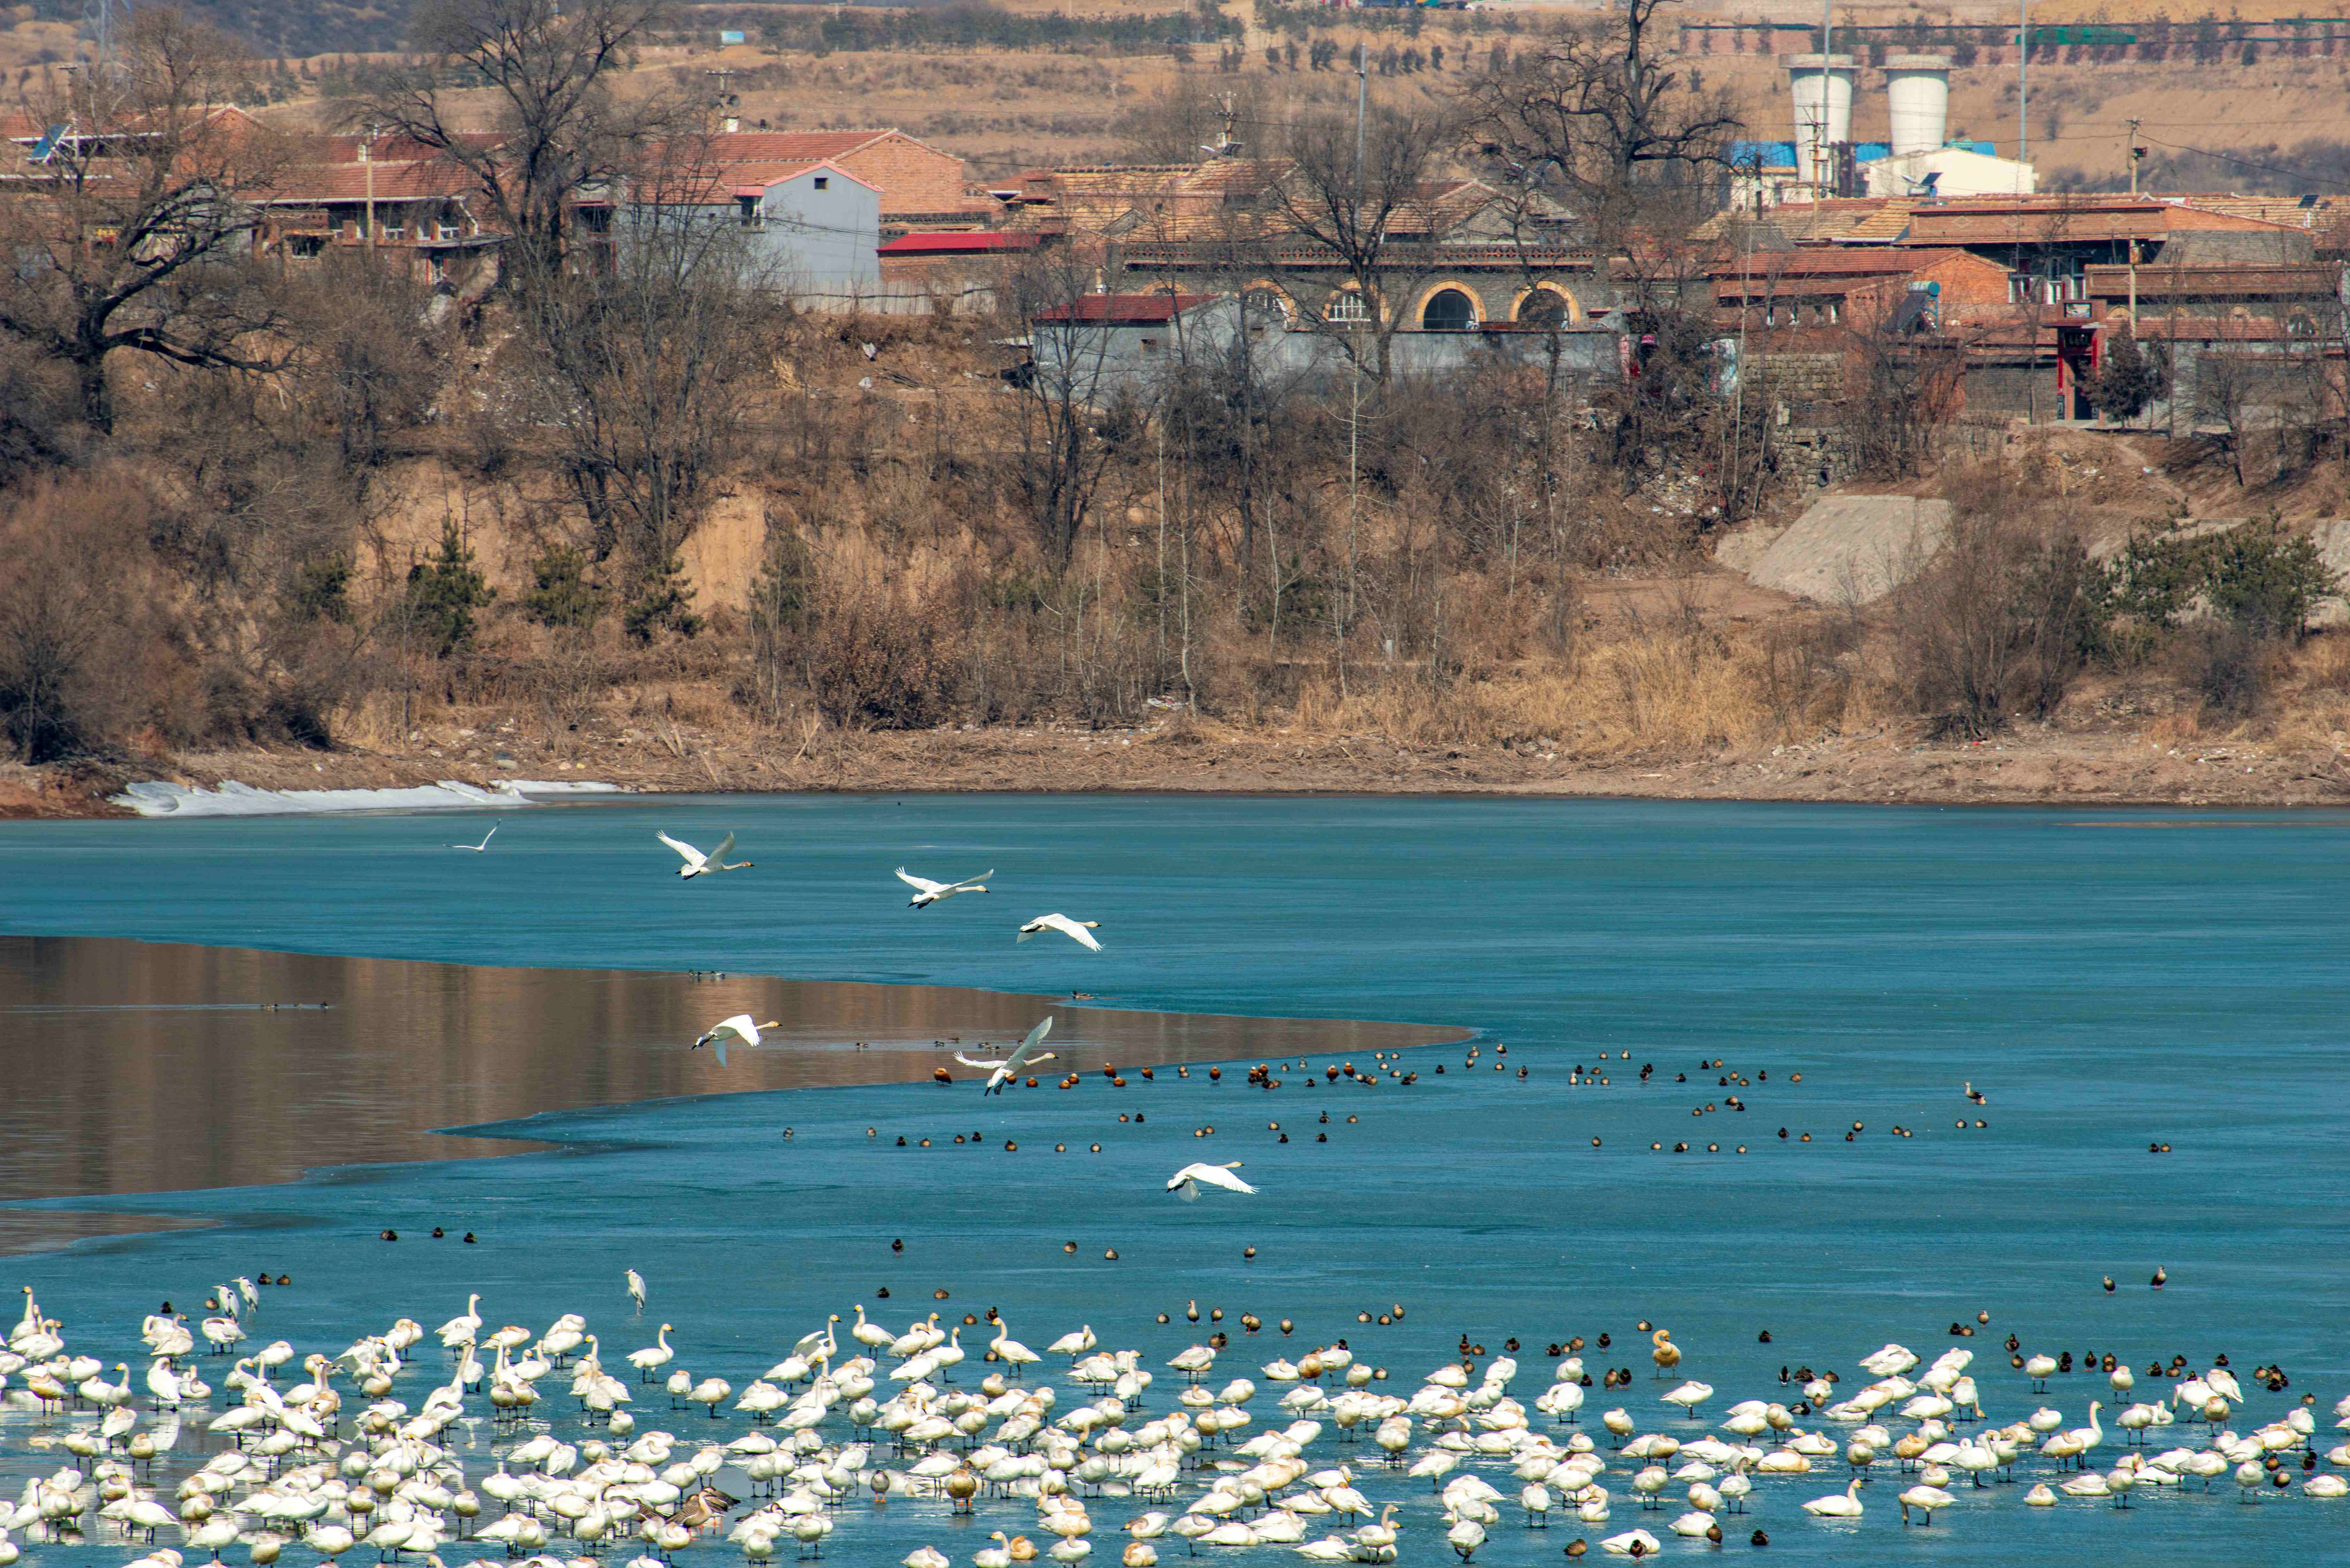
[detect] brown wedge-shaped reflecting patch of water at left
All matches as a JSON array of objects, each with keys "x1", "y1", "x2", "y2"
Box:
[{"x1": 0, "y1": 936, "x2": 1459, "y2": 1251}]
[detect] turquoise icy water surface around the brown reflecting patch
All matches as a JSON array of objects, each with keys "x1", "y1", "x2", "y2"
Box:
[{"x1": 0, "y1": 797, "x2": 2350, "y2": 1563}]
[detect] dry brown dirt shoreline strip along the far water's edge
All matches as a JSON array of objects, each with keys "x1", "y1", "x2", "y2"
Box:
[{"x1": 23, "y1": 724, "x2": 2350, "y2": 818}]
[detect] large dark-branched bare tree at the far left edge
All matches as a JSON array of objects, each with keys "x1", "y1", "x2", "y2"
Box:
[{"x1": 0, "y1": 7, "x2": 284, "y2": 430}]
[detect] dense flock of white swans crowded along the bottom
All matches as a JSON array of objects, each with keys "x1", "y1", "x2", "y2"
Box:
[{"x1": 0, "y1": 1279, "x2": 2350, "y2": 1568}]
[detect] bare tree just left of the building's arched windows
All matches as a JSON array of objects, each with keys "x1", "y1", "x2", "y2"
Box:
[{"x1": 1264, "y1": 108, "x2": 1452, "y2": 383}]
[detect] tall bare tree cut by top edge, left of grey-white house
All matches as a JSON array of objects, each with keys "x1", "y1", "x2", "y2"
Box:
[{"x1": 343, "y1": 0, "x2": 696, "y2": 287}]
